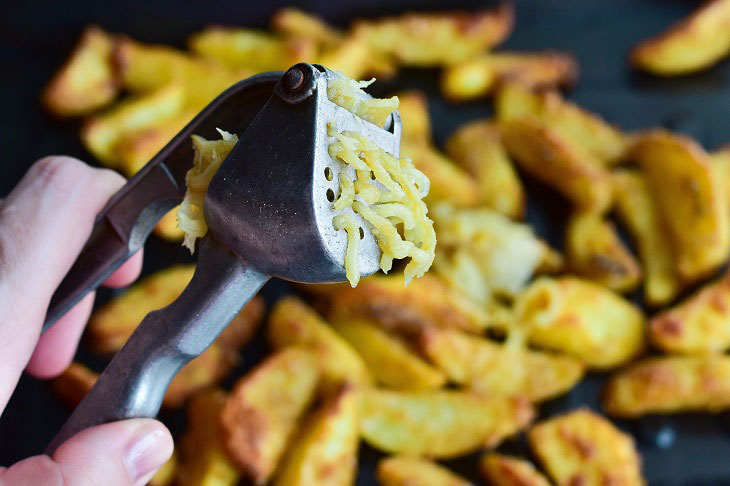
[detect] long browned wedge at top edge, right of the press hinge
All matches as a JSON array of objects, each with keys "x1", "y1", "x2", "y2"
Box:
[{"x1": 353, "y1": 3, "x2": 514, "y2": 66}]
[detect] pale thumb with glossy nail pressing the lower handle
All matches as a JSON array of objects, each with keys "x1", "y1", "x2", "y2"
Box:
[{"x1": 0, "y1": 419, "x2": 173, "y2": 486}]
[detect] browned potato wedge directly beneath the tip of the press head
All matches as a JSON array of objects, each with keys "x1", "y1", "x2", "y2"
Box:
[{"x1": 331, "y1": 274, "x2": 488, "y2": 334}]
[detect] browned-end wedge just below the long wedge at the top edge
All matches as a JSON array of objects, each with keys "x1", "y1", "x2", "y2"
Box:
[{"x1": 441, "y1": 51, "x2": 578, "y2": 101}]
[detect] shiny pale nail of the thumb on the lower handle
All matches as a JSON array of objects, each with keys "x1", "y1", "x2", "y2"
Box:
[{"x1": 124, "y1": 426, "x2": 172, "y2": 484}]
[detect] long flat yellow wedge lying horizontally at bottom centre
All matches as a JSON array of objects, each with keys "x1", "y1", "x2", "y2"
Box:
[{"x1": 360, "y1": 388, "x2": 535, "y2": 458}]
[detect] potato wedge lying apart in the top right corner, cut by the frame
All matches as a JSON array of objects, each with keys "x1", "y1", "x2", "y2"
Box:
[{"x1": 630, "y1": 0, "x2": 730, "y2": 76}]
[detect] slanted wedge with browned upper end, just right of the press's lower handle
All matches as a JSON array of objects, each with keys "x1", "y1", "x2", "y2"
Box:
[{"x1": 267, "y1": 296, "x2": 373, "y2": 386}]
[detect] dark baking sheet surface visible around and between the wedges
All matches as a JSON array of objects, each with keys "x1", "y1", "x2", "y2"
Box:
[{"x1": 0, "y1": 0, "x2": 730, "y2": 486}]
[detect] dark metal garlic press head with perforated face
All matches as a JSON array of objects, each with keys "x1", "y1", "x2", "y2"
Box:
[{"x1": 204, "y1": 63, "x2": 401, "y2": 282}]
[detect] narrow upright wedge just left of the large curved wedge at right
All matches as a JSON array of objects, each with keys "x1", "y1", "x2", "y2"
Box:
[{"x1": 613, "y1": 169, "x2": 679, "y2": 306}]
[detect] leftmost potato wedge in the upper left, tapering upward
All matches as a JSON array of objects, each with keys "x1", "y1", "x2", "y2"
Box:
[{"x1": 41, "y1": 25, "x2": 119, "y2": 116}]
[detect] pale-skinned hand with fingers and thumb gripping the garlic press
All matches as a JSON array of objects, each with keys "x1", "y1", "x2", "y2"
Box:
[{"x1": 0, "y1": 156, "x2": 173, "y2": 486}]
